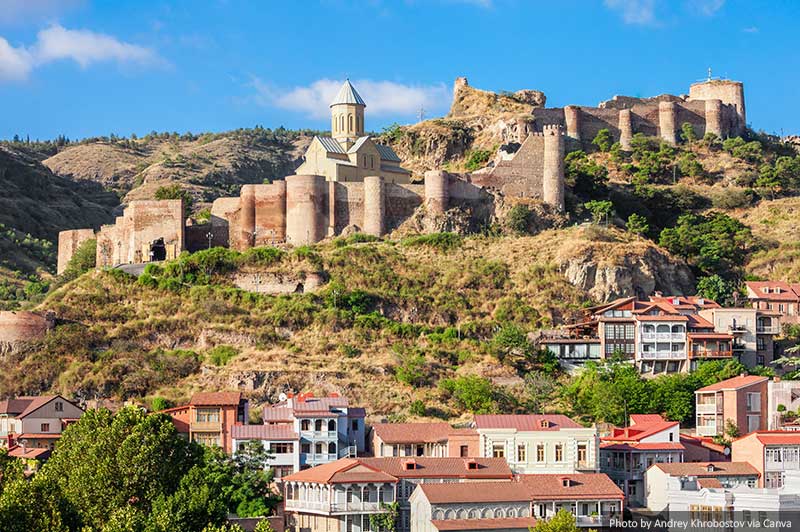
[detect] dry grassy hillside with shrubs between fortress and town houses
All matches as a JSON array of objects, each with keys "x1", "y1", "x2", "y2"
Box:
[{"x1": 0, "y1": 227, "x2": 691, "y2": 417}]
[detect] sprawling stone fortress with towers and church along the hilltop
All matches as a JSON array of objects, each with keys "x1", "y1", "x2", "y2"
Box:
[{"x1": 58, "y1": 78, "x2": 746, "y2": 273}]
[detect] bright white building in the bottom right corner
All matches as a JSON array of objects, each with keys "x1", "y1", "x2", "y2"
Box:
[{"x1": 664, "y1": 471, "x2": 800, "y2": 520}]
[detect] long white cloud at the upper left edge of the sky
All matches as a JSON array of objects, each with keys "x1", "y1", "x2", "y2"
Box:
[{"x1": 0, "y1": 24, "x2": 163, "y2": 80}]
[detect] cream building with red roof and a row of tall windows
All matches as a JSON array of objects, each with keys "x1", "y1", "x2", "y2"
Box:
[{"x1": 474, "y1": 414, "x2": 599, "y2": 474}]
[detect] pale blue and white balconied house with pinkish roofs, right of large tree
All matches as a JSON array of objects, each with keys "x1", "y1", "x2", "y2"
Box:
[{"x1": 233, "y1": 393, "x2": 366, "y2": 477}]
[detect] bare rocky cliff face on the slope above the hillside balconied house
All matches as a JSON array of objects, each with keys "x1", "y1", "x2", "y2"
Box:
[{"x1": 559, "y1": 243, "x2": 694, "y2": 301}]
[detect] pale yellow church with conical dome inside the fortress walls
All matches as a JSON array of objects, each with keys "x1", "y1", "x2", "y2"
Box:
[{"x1": 295, "y1": 79, "x2": 411, "y2": 183}]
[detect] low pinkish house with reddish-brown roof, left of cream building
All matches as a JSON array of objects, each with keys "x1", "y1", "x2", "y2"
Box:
[{"x1": 372, "y1": 423, "x2": 478, "y2": 458}]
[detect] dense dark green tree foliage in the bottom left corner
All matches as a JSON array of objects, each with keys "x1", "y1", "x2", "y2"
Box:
[{"x1": 0, "y1": 407, "x2": 274, "y2": 532}]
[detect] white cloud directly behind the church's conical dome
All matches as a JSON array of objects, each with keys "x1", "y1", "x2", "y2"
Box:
[{"x1": 252, "y1": 79, "x2": 451, "y2": 118}]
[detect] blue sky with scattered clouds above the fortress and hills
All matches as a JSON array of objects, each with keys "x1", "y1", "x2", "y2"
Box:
[{"x1": 0, "y1": 0, "x2": 800, "y2": 139}]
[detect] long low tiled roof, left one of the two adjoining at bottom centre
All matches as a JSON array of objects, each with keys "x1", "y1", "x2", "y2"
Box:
[{"x1": 418, "y1": 481, "x2": 531, "y2": 504}]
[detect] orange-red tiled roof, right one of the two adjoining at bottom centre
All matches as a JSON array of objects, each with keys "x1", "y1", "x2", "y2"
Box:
[{"x1": 519, "y1": 473, "x2": 624, "y2": 501}]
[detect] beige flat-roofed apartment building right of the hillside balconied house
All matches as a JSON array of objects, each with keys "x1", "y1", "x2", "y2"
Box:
[{"x1": 700, "y1": 308, "x2": 780, "y2": 367}]
